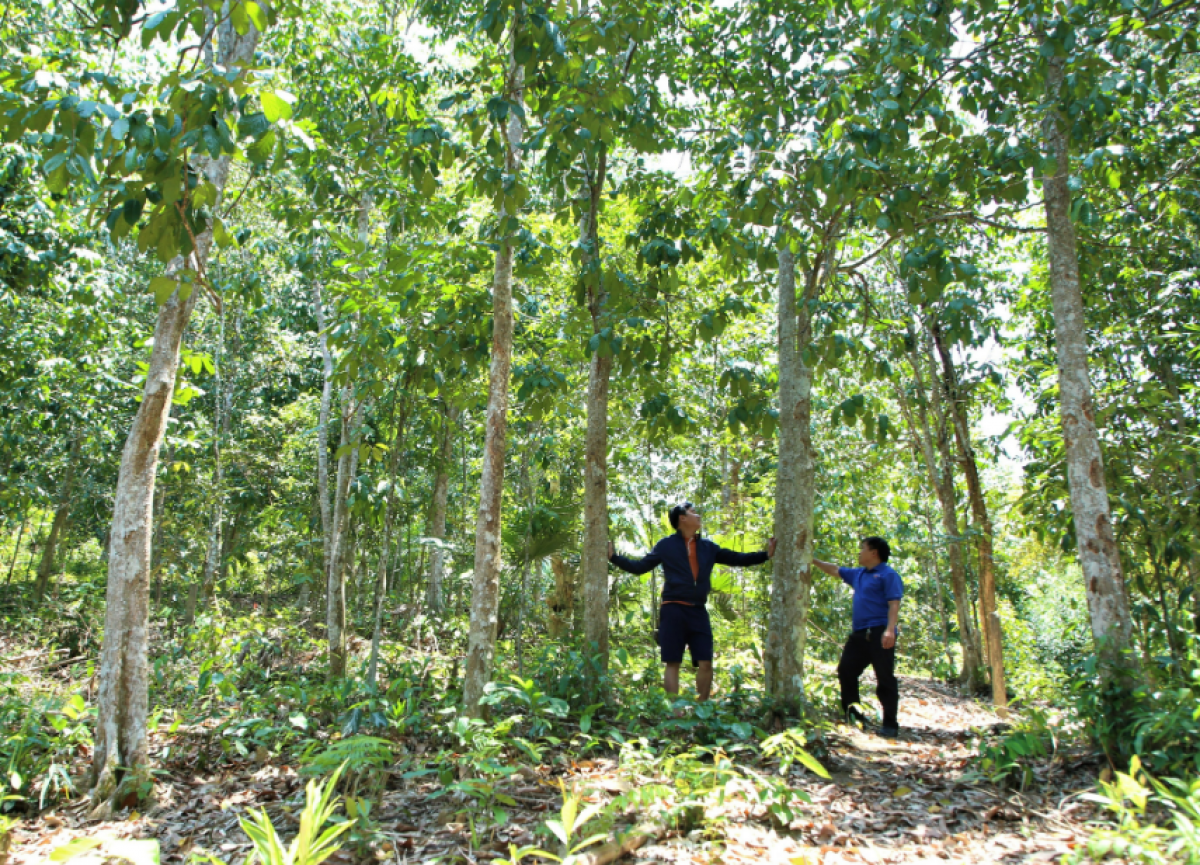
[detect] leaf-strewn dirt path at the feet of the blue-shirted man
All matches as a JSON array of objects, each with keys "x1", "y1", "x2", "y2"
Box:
[{"x1": 630, "y1": 677, "x2": 1099, "y2": 865}]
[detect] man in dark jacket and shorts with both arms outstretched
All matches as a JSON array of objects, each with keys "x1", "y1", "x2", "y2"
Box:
[{"x1": 608, "y1": 501, "x2": 775, "y2": 699}]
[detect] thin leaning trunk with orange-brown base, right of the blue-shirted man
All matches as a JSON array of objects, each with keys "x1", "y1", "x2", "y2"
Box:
[{"x1": 932, "y1": 323, "x2": 1008, "y2": 709}]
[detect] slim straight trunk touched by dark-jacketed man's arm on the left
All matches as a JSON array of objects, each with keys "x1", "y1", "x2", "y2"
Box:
[{"x1": 580, "y1": 143, "x2": 612, "y2": 676}]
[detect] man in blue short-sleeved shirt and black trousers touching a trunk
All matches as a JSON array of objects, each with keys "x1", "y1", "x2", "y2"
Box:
[{"x1": 812, "y1": 537, "x2": 904, "y2": 739}]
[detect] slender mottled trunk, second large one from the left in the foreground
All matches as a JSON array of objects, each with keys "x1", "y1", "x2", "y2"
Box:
[{"x1": 462, "y1": 8, "x2": 524, "y2": 717}]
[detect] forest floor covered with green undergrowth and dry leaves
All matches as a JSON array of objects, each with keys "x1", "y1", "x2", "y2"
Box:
[{"x1": 0, "y1": 595, "x2": 1196, "y2": 865}]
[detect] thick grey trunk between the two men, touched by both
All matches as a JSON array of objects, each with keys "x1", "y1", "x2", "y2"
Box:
[{"x1": 763, "y1": 238, "x2": 823, "y2": 710}]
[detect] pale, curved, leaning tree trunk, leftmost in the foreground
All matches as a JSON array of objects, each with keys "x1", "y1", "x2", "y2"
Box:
[{"x1": 91, "y1": 10, "x2": 259, "y2": 818}]
